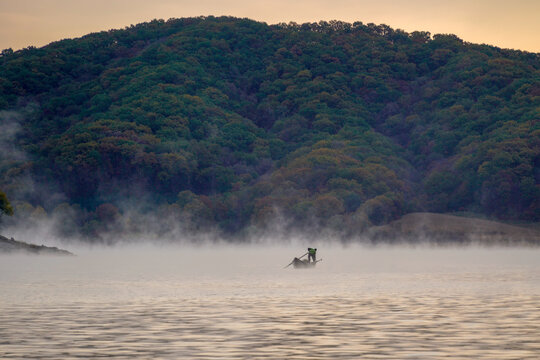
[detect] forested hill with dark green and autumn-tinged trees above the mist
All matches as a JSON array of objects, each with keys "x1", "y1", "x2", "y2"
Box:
[{"x1": 0, "y1": 17, "x2": 540, "y2": 239}]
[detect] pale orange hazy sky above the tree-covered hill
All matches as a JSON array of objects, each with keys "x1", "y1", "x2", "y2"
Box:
[{"x1": 0, "y1": 0, "x2": 540, "y2": 52}]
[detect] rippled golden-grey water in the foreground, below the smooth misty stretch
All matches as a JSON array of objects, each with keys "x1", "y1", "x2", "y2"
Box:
[{"x1": 0, "y1": 295, "x2": 540, "y2": 359}]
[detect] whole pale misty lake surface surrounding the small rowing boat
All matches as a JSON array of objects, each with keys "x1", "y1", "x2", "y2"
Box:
[{"x1": 0, "y1": 244, "x2": 540, "y2": 359}]
